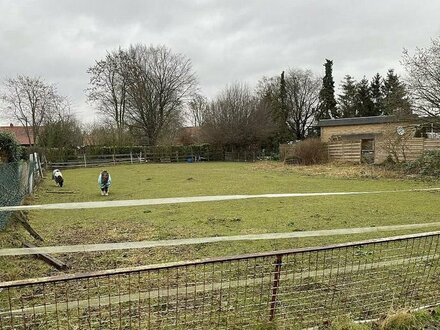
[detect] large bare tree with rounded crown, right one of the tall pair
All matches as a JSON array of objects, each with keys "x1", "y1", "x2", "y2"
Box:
[{"x1": 122, "y1": 45, "x2": 197, "y2": 145}]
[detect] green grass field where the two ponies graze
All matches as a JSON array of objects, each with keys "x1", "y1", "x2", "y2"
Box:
[{"x1": 0, "y1": 162, "x2": 440, "y2": 280}]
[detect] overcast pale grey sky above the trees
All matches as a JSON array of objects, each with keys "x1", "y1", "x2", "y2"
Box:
[{"x1": 0, "y1": 0, "x2": 440, "y2": 124}]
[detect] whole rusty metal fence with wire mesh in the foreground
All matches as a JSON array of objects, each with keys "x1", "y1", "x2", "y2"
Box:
[{"x1": 0, "y1": 232, "x2": 440, "y2": 329}]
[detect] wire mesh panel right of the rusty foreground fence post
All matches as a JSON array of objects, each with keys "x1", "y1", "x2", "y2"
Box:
[{"x1": 275, "y1": 236, "x2": 440, "y2": 326}]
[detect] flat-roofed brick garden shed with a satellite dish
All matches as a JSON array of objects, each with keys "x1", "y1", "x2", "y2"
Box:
[{"x1": 317, "y1": 116, "x2": 440, "y2": 164}]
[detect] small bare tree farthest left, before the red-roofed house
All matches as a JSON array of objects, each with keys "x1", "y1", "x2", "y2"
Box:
[{"x1": 1, "y1": 76, "x2": 65, "y2": 145}]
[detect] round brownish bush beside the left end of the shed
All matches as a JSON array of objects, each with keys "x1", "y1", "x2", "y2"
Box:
[{"x1": 288, "y1": 138, "x2": 328, "y2": 165}]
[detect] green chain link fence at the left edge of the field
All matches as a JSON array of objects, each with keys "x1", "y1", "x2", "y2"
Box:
[{"x1": 0, "y1": 161, "x2": 37, "y2": 230}]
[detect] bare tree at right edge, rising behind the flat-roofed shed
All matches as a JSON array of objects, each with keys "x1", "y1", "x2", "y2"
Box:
[{"x1": 402, "y1": 36, "x2": 440, "y2": 117}]
